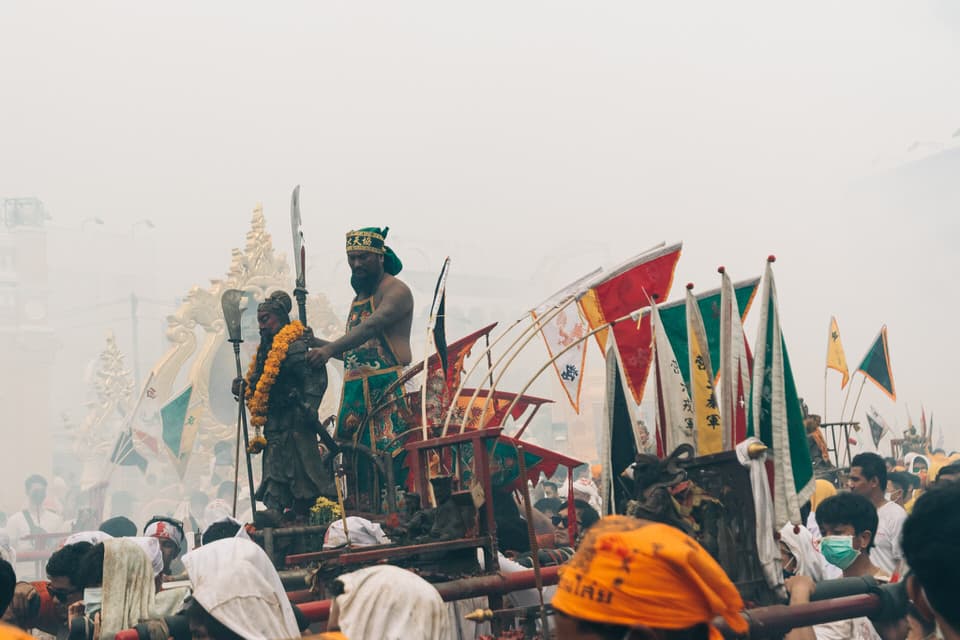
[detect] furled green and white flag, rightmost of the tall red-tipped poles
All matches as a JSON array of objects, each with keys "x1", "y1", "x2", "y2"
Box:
[{"x1": 747, "y1": 262, "x2": 814, "y2": 529}]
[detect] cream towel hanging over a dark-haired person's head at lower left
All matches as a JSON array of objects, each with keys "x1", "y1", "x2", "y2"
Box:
[{"x1": 100, "y1": 538, "x2": 155, "y2": 640}]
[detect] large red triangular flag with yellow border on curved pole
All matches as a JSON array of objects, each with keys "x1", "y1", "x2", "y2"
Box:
[{"x1": 580, "y1": 243, "x2": 683, "y2": 404}]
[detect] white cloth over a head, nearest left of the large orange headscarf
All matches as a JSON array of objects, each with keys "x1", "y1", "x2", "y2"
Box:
[{"x1": 334, "y1": 564, "x2": 451, "y2": 640}]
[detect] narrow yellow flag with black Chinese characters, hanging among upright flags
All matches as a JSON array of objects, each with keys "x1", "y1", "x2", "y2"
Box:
[{"x1": 687, "y1": 285, "x2": 723, "y2": 456}]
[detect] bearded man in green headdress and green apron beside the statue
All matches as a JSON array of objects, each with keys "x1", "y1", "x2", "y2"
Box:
[{"x1": 307, "y1": 227, "x2": 413, "y2": 464}]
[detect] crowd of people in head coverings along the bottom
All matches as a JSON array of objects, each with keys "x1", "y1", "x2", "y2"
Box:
[{"x1": 0, "y1": 453, "x2": 960, "y2": 640}]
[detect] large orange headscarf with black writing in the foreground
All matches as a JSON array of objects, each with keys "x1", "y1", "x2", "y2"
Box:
[{"x1": 552, "y1": 516, "x2": 748, "y2": 639}]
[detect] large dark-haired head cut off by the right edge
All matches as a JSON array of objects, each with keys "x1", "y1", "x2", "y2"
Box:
[{"x1": 903, "y1": 482, "x2": 960, "y2": 640}]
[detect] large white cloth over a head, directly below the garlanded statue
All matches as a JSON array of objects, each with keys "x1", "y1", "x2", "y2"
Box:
[{"x1": 183, "y1": 538, "x2": 300, "y2": 640}]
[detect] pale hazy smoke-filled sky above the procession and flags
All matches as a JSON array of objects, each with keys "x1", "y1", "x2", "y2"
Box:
[{"x1": 0, "y1": 0, "x2": 960, "y2": 460}]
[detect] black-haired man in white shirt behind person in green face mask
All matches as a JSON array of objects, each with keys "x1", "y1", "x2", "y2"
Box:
[{"x1": 852, "y1": 453, "x2": 907, "y2": 575}]
